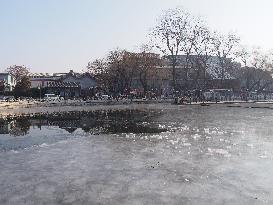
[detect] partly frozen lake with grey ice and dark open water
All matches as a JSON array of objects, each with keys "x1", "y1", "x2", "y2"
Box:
[{"x1": 0, "y1": 105, "x2": 273, "y2": 205}]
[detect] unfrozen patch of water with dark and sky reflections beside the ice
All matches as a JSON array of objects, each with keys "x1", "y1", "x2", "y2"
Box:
[{"x1": 0, "y1": 110, "x2": 167, "y2": 151}]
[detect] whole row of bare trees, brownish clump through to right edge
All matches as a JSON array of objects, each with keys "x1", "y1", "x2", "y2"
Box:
[{"x1": 87, "y1": 8, "x2": 273, "y2": 93}]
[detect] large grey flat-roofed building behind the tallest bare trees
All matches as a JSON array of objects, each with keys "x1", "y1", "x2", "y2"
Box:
[{"x1": 163, "y1": 55, "x2": 241, "y2": 90}]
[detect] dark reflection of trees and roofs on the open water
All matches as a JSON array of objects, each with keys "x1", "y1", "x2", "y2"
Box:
[{"x1": 0, "y1": 110, "x2": 167, "y2": 136}]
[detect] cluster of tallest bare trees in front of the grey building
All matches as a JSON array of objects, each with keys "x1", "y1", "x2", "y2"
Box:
[{"x1": 152, "y1": 8, "x2": 240, "y2": 90}]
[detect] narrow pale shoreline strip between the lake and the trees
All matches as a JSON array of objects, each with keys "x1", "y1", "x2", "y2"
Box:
[{"x1": 0, "y1": 100, "x2": 273, "y2": 118}]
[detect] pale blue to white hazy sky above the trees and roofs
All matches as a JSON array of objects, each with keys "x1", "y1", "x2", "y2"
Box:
[{"x1": 0, "y1": 0, "x2": 273, "y2": 72}]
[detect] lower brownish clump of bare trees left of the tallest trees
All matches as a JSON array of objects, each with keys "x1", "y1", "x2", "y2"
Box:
[{"x1": 87, "y1": 46, "x2": 161, "y2": 94}]
